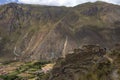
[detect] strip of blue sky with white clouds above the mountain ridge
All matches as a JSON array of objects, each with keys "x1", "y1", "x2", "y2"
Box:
[{"x1": 0, "y1": 0, "x2": 120, "y2": 6}]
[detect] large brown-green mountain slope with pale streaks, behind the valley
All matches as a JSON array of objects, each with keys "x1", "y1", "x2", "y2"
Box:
[{"x1": 0, "y1": 2, "x2": 120, "y2": 61}]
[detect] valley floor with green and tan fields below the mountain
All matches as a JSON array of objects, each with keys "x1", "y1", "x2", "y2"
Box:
[{"x1": 0, "y1": 61, "x2": 54, "y2": 80}]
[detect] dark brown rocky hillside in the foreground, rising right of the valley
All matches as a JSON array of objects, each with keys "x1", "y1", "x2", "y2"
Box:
[{"x1": 46, "y1": 46, "x2": 120, "y2": 80}]
